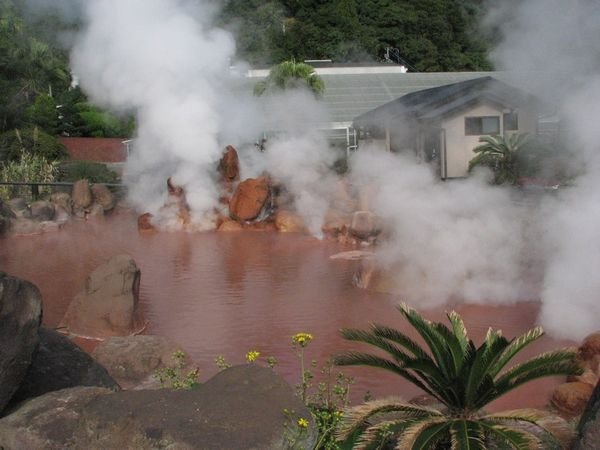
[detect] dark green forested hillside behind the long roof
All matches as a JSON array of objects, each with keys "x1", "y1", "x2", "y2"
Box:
[{"x1": 222, "y1": 0, "x2": 491, "y2": 72}]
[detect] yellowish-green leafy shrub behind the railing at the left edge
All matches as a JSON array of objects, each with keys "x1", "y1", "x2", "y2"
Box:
[{"x1": 0, "y1": 152, "x2": 58, "y2": 201}]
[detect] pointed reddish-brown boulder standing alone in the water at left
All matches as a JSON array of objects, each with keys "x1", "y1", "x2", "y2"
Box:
[{"x1": 61, "y1": 255, "x2": 143, "y2": 338}]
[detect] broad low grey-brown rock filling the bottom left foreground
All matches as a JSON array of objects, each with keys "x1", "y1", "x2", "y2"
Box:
[{"x1": 0, "y1": 365, "x2": 317, "y2": 450}]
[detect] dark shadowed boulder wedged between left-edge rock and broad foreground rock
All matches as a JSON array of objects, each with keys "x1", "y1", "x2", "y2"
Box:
[{"x1": 6, "y1": 327, "x2": 119, "y2": 405}]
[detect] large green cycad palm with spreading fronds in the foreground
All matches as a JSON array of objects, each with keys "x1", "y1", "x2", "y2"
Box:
[{"x1": 335, "y1": 304, "x2": 581, "y2": 450}]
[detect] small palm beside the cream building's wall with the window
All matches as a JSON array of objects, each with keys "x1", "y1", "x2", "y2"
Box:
[{"x1": 469, "y1": 133, "x2": 529, "y2": 184}]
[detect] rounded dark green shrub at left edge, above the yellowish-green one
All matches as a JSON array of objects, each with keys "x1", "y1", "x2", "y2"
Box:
[{"x1": 0, "y1": 127, "x2": 68, "y2": 162}]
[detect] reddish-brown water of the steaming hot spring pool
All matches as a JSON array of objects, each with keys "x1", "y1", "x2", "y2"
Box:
[{"x1": 0, "y1": 215, "x2": 576, "y2": 409}]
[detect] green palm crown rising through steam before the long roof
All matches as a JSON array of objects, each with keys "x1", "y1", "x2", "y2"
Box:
[{"x1": 254, "y1": 59, "x2": 325, "y2": 97}]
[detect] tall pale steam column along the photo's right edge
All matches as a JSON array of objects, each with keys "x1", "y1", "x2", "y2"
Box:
[{"x1": 490, "y1": 0, "x2": 600, "y2": 339}]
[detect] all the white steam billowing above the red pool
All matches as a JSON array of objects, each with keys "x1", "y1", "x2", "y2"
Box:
[{"x1": 36, "y1": 0, "x2": 600, "y2": 339}]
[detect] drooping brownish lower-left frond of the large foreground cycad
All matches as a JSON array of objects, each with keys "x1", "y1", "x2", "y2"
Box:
[{"x1": 336, "y1": 397, "x2": 442, "y2": 440}]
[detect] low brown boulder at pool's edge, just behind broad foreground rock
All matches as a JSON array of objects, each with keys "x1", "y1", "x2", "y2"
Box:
[{"x1": 92, "y1": 335, "x2": 193, "y2": 389}]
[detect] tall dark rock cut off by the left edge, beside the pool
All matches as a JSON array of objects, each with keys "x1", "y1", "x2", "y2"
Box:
[{"x1": 0, "y1": 272, "x2": 42, "y2": 412}]
